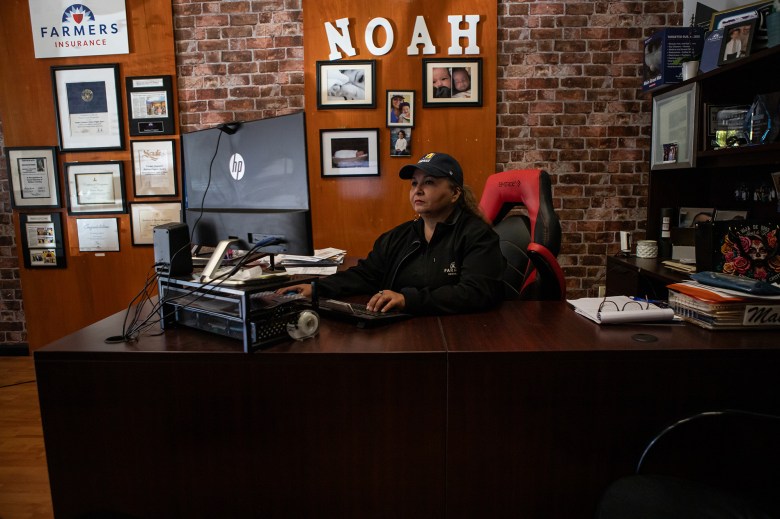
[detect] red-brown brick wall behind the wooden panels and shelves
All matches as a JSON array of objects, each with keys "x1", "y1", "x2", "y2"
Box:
[{"x1": 0, "y1": 0, "x2": 682, "y2": 350}]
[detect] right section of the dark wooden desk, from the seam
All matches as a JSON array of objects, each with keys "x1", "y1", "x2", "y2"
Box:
[{"x1": 441, "y1": 302, "x2": 780, "y2": 518}]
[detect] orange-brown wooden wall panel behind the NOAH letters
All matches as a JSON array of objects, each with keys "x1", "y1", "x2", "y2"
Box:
[{"x1": 303, "y1": 0, "x2": 497, "y2": 256}]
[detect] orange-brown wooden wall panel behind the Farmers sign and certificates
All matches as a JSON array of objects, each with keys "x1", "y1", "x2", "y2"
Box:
[{"x1": 0, "y1": 0, "x2": 175, "y2": 349}]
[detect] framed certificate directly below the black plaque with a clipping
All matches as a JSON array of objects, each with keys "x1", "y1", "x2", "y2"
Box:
[{"x1": 130, "y1": 140, "x2": 178, "y2": 197}]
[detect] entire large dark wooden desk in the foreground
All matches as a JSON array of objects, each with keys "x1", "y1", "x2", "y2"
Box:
[{"x1": 35, "y1": 302, "x2": 780, "y2": 518}]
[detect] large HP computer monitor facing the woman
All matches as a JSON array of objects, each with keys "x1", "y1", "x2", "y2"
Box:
[{"x1": 181, "y1": 112, "x2": 314, "y2": 255}]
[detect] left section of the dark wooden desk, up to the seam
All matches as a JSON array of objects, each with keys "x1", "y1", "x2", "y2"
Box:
[{"x1": 35, "y1": 310, "x2": 447, "y2": 518}]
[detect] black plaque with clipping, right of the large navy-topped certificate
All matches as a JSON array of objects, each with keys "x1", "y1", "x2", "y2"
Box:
[{"x1": 125, "y1": 76, "x2": 176, "y2": 136}]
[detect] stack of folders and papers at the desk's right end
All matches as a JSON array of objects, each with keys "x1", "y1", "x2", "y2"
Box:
[{"x1": 667, "y1": 281, "x2": 780, "y2": 330}]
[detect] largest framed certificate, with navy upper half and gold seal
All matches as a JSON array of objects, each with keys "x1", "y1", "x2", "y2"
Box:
[{"x1": 51, "y1": 64, "x2": 124, "y2": 151}]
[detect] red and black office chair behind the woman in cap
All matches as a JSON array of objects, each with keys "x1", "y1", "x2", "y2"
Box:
[{"x1": 479, "y1": 169, "x2": 566, "y2": 300}]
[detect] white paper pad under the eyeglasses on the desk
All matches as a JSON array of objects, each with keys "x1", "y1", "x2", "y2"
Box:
[{"x1": 569, "y1": 296, "x2": 674, "y2": 324}]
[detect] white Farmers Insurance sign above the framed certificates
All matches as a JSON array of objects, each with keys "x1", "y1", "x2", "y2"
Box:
[{"x1": 29, "y1": 0, "x2": 129, "y2": 58}]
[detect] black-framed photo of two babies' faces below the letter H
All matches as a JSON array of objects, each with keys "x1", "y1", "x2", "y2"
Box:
[{"x1": 422, "y1": 58, "x2": 482, "y2": 108}]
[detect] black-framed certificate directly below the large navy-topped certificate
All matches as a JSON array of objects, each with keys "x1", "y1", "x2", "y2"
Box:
[{"x1": 65, "y1": 161, "x2": 127, "y2": 214}]
